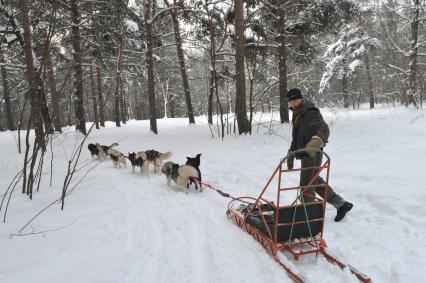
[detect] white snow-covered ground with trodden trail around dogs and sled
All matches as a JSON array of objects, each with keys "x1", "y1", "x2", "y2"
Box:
[{"x1": 0, "y1": 108, "x2": 426, "y2": 283}]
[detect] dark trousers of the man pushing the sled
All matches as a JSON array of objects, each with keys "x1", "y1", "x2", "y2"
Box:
[{"x1": 300, "y1": 152, "x2": 345, "y2": 209}]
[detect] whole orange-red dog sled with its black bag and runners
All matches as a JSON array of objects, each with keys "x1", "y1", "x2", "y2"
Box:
[{"x1": 226, "y1": 149, "x2": 372, "y2": 283}]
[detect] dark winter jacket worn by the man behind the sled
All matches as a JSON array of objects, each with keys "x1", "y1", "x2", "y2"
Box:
[{"x1": 290, "y1": 100, "x2": 330, "y2": 159}]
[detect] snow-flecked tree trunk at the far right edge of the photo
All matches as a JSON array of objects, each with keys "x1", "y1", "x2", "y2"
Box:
[{"x1": 407, "y1": 0, "x2": 420, "y2": 107}]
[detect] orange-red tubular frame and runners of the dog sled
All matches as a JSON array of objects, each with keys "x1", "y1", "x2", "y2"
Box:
[{"x1": 226, "y1": 149, "x2": 372, "y2": 283}]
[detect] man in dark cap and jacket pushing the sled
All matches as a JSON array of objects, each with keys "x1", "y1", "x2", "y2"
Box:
[{"x1": 287, "y1": 88, "x2": 353, "y2": 222}]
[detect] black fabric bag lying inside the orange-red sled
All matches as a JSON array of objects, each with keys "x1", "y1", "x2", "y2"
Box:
[{"x1": 246, "y1": 203, "x2": 324, "y2": 242}]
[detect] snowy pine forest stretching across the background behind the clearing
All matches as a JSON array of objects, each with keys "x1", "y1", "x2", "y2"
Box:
[{"x1": 0, "y1": 0, "x2": 426, "y2": 140}]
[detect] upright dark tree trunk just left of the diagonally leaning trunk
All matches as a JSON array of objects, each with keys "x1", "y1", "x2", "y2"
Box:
[{"x1": 144, "y1": 0, "x2": 158, "y2": 134}]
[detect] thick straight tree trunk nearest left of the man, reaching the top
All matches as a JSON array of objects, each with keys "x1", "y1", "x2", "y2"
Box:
[{"x1": 234, "y1": 0, "x2": 250, "y2": 135}]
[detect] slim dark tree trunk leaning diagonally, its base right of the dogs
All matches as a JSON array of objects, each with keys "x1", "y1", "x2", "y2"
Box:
[{"x1": 165, "y1": 0, "x2": 195, "y2": 124}]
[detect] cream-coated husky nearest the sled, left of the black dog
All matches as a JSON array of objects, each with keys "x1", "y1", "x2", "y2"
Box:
[{"x1": 161, "y1": 161, "x2": 199, "y2": 192}]
